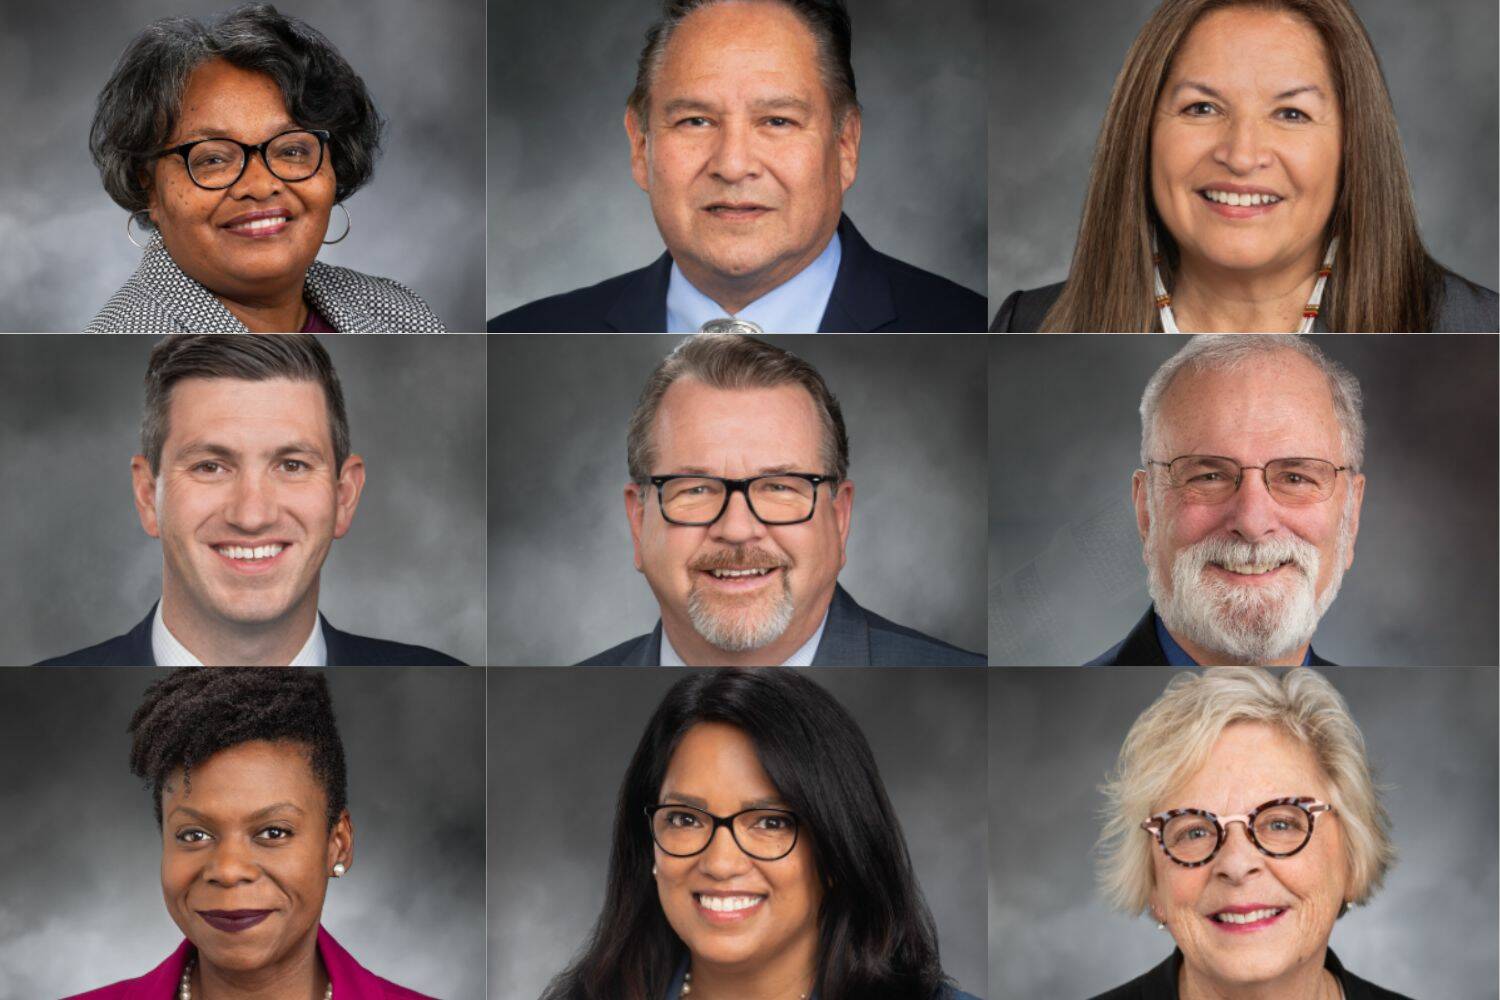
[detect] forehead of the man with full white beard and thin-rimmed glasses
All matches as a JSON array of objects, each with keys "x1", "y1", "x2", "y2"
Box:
[{"x1": 1157, "y1": 351, "x2": 1344, "y2": 463}]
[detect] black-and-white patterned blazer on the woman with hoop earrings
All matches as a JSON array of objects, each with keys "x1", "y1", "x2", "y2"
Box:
[{"x1": 84, "y1": 232, "x2": 444, "y2": 333}]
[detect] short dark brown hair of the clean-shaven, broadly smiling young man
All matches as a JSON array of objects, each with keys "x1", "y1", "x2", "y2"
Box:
[{"x1": 141, "y1": 333, "x2": 350, "y2": 475}]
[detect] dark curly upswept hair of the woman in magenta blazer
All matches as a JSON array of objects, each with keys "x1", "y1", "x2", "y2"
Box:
[{"x1": 129, "y1": 667, "x2": 348, "y2": 828}]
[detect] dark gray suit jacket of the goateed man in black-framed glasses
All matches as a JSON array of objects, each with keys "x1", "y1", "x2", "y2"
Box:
[{"x1": 578, "y1": 585, "x2": 984, "y2": 667}]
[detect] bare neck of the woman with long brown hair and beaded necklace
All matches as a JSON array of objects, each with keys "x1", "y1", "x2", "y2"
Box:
[{"x1": 1172, "y1": 256, "x2": 1319, "y2": 333}]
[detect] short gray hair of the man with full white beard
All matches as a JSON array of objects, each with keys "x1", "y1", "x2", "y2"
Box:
[{"x1": 1140, "y1": 333, "x2": 1365, "y2": 472}]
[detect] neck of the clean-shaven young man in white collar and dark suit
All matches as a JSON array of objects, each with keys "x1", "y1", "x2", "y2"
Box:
[{"x1": 162, "y1": 580, "x2": 318, "y2": 667}]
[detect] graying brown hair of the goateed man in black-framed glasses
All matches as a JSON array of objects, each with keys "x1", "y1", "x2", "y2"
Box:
[{"x1": 626, "y1": 333, "x2": 849, "y2": 486}]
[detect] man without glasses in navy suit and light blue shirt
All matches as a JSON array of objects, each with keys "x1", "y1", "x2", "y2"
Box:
[{"x1": 489, "y1": 0, "x2": 986, "y2": 333}]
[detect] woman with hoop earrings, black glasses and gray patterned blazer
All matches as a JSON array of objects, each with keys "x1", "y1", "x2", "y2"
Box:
[{"x1": 87, "y1": 3, "x2": 443, "y2": 333}]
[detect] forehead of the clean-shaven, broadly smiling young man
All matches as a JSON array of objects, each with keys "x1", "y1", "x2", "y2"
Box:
[{"x1": 164, "y1": 378, "x2": 332, "y2": 450}]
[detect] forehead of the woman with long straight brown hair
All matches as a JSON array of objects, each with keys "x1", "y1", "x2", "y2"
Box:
[{"x1": 1167, "y1": 4, "x2": 1334, "y2": 97}]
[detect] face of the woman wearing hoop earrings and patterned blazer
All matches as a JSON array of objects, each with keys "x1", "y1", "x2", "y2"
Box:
[{"x1": 150, "y1": 58, "x2": 336, "y2": 303}]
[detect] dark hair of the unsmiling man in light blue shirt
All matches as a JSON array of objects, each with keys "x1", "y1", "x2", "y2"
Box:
[{"x1": 626, "y1": 0, "x2": 860, "y2": 129}]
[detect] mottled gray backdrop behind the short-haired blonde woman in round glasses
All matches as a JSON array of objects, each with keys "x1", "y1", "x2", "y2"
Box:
[{"x1": 989, "y1": 667, "x2": 1500, "y2": 1000}]
